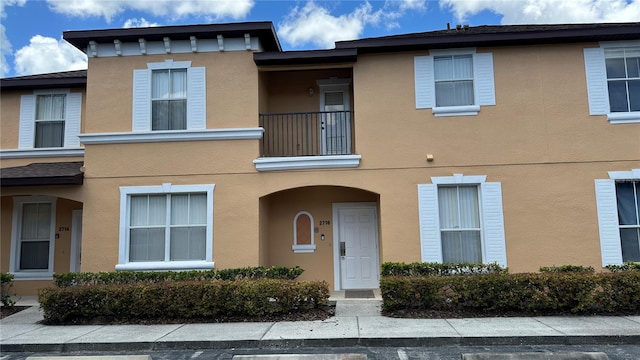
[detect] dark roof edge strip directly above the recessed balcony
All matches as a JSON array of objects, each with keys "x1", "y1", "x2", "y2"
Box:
[{"x1": 253, "y1": 49, "x2": 358, "y2": 65}]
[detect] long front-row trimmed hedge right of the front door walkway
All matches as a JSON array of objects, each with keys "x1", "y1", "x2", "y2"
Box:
[{"x1": 380, "y1": 272, "x2": 640, "y2": 316}]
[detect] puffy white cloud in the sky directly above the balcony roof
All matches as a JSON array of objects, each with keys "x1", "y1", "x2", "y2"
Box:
[{"x1": 278, "y1": 1, "x2": 383, "y2": 48}]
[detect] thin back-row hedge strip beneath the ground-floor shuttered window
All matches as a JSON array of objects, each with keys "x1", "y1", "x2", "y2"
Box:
[{"x1": 381, "y1": 262, "x2": 507, "y2": 276}]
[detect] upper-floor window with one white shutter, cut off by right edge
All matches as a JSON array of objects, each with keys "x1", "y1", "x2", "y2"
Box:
[{"x1": 584, "y1": 41, "x2": 640, "y2": 123}]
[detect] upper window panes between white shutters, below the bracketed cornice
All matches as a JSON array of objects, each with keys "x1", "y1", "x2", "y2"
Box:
[{"x1": 151, "y1": 69, "x2": 187, "y2": 130}]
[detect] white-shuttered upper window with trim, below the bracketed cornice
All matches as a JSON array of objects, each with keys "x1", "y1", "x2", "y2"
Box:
[{"x1": 132, "y1": 60, "x2": 206, "y2": 132}]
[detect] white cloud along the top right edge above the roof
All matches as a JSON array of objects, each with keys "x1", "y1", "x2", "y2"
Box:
[{"x1": 440, "y1": 0, "x2": 640, "y2": 24}]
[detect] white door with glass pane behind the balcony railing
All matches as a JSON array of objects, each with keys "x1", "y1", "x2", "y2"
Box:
[{"x1": 318, "y1": 79, "x2": 351, "y2": 155}]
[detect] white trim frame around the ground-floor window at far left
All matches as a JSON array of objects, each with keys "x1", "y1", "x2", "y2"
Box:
[{"x1": 9, "y1": 196, "x2": 56, "y2": 280}]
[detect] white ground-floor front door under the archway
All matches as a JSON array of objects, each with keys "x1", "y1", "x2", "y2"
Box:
[{"x1": 333, "y1": 203, "x2": 380, "y2": 289}]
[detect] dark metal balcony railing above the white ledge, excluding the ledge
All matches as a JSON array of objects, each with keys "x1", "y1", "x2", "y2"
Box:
[{"x1": 260, "y1": 111, "x2": 353, "y2": 157}]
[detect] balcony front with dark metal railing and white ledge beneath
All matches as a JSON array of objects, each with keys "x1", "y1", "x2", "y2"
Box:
[{"x1": 254, "y1": 111, "x2": 360, "y2": 171}]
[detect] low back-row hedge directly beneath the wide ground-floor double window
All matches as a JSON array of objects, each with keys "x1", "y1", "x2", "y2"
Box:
[{"x1": 53, "y1": 266, "x2": 304, "y2": 287}]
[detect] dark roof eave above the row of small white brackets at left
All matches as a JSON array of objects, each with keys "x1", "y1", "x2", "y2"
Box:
[{"x1": 62, "y1": 21, "x2": 282, "y2": 51}]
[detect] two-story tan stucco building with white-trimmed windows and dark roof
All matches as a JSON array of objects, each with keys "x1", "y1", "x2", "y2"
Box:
[{"x1": 0, "y1": 22, "x2": 640, "y2": 295}]
